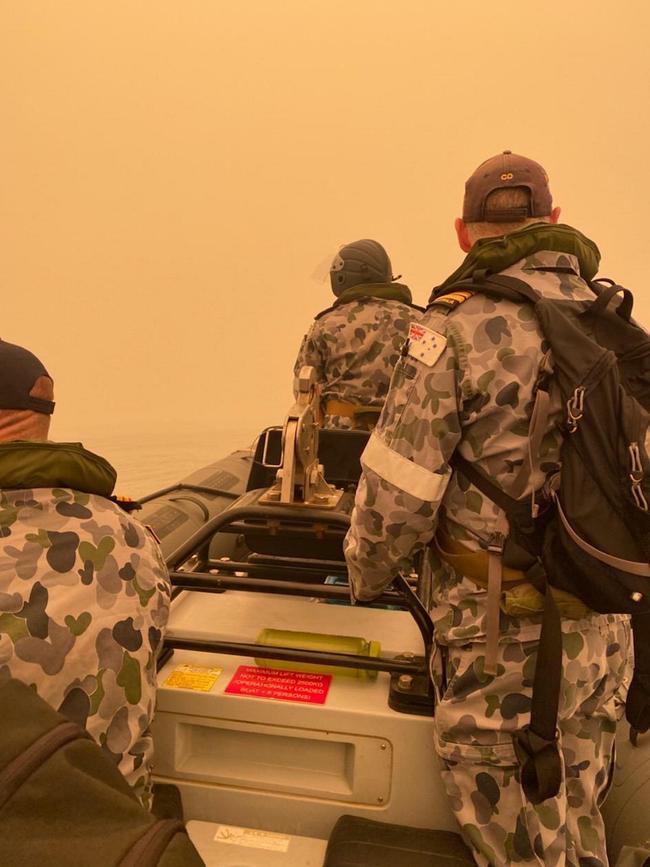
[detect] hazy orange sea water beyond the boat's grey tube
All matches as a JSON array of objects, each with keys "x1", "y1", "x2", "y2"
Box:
[{"x1": 58, "y1": 427, "x2": 260, "y2": 499}]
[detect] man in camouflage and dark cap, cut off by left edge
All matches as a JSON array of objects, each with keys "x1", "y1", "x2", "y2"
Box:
[{"x1": 0, "y1": 341, "x2": 170, "y2": 806}]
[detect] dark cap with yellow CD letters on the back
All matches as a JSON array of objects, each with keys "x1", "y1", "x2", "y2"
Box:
[{"x1": 463, "y1": 151, "x2": 553, "y2": 223}]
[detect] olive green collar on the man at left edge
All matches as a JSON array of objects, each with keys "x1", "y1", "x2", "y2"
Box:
[{"x1": 0, "y1": 440, "x2": 117, "y2": 497}]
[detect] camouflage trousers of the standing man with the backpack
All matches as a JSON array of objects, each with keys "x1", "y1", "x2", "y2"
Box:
[{"x1": 434, "y1": 615, "x2": 633, "y2": 867}]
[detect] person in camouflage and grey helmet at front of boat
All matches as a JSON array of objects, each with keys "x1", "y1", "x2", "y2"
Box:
[{"x1": 294, "y1": 240, "x2": 422, "y2": 430}]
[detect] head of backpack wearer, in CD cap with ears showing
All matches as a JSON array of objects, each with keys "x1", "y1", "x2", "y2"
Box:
[{"x1": 456, "y1": 151, "x2": 560, "y2": 252}]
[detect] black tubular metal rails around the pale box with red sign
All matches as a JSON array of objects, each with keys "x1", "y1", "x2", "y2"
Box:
[{"x1": 158, "y1": 504, "x2": 433, "y2": 675}]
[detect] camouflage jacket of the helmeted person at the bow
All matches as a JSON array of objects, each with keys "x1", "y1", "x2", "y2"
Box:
[{"x1": 294, "y1": 284, "x2": 422, "y2": 428}]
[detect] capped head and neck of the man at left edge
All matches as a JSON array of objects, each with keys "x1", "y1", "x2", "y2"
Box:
[{"x1": 0, "y1": 340, "x2": 54, "y2": 442}]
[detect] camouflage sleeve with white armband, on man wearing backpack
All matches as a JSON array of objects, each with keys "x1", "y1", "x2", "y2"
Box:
[{"x1": 345, "y1": 329, "x2": 463, "y2": 601}]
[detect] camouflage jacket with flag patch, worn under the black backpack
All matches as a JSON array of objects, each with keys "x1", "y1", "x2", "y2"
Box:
[{"x1": 346, "y1": 237, "x2": 624, "y2": 643}]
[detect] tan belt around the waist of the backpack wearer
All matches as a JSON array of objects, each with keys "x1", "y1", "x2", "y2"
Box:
[{"x1": 432, "y1": 529, "x2": 593, "y2": 620}]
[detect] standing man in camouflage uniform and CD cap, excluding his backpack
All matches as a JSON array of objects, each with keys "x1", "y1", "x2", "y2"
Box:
[{"x1": 346, "y1": 152, "x2": 632, "y2": 867}]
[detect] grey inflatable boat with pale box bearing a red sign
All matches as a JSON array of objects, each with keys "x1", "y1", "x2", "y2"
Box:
[{"x1": 138, "y1": 374, "x2": 650, "y2": 867}]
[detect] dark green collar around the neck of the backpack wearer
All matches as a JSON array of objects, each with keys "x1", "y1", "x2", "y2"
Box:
[{"x1": 432, "y1": 223, "x2": 600, "y2": 298}]
